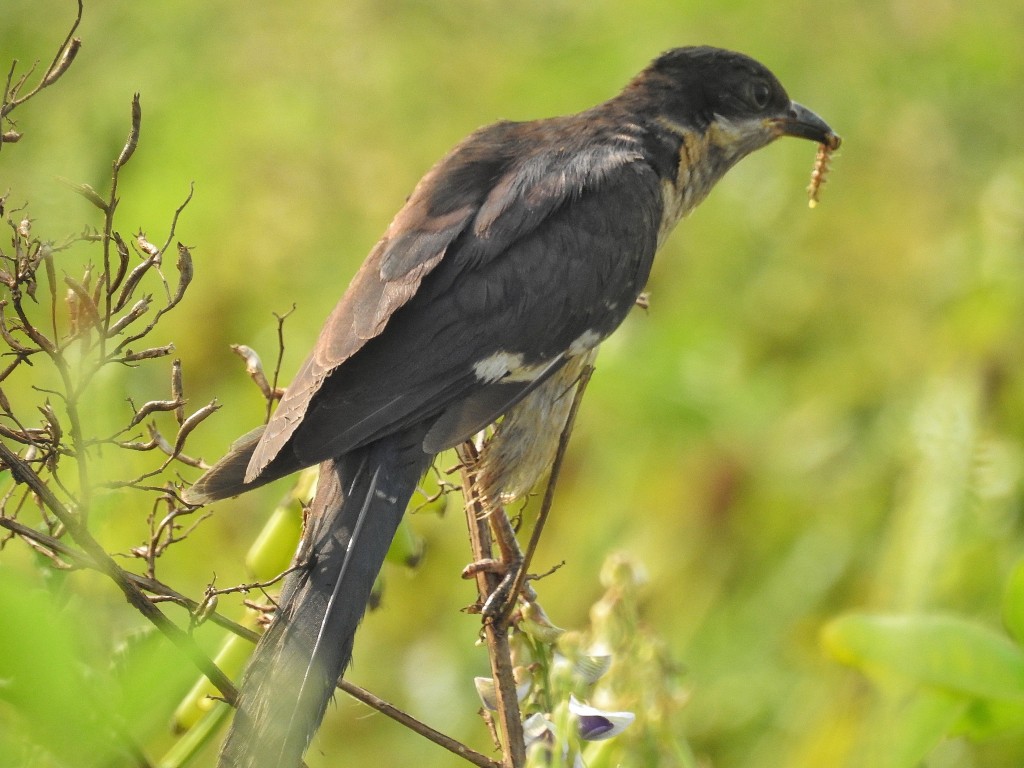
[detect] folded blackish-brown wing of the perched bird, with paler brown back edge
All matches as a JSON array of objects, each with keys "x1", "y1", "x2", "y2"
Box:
[{"x1": 247, "y1": 118, "x2": 660, "y2": 479}]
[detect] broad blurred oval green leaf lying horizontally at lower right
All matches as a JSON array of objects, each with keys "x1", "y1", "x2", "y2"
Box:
[{"x1": 822, "y1": 613, "x2": 1024, "y2": 701}]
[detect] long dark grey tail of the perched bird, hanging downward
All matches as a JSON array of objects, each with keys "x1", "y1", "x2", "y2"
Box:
[{"x1": 219, "y1": 433, "x2": 431, "y2": 768}]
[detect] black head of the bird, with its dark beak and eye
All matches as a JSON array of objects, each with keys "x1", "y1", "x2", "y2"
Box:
[{"x1": 623, "y1": 47, "x2": 840, "y2": 173}]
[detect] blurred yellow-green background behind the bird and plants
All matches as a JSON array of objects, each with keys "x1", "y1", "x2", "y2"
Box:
[{"x1": 0, "y1": 0, "x2": 1024, "y2": 768}]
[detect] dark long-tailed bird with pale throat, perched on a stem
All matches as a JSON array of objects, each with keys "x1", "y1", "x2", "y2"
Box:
[{"x1": 182, "y1": 46, "x2": 840, "y2": 768}]
